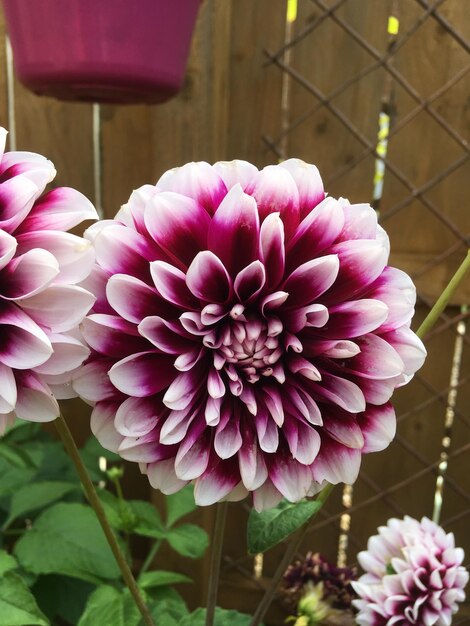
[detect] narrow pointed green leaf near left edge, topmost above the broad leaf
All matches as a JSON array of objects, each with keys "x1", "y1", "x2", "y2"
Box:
[{"x1": 5, "y1": 481, "x2": 79, "y2": 526}]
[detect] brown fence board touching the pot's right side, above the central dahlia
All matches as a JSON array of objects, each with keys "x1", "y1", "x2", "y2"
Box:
[{"x1": 102, "y1": 0, "x2": 231, "y2": 216}]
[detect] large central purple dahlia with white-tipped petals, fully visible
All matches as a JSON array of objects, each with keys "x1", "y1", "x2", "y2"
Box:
[{"x1": 74, "y1": 159, "x2": 425, "y2": 509}]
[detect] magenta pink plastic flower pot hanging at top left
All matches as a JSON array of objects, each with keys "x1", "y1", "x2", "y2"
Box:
[{"x1": 3, "y1": 0, "x2": 200, "y2": 103}]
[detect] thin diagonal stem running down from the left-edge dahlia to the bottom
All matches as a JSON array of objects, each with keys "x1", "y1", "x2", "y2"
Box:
[{"x1": 54, "y1": 415, "x2": 155, "y2": 626}]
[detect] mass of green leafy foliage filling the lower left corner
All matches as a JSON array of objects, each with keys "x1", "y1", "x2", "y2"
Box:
[{"x1": 0, "y1": 422, "x2": 209, "y2": 626}]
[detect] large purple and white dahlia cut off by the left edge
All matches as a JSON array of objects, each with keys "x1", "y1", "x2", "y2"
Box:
[{"x1": 0, "y1": 128, "x2": 98, "y2": 434}]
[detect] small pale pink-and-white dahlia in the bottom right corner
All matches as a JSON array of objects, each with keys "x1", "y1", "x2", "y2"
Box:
[{"x1": 353, "y1": 517, "x2": 468, "y2": 626}]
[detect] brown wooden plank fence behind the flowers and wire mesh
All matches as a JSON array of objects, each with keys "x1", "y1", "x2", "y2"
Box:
[{"x1": 0, "y1": 0, "x2": 470, "y2": 623}]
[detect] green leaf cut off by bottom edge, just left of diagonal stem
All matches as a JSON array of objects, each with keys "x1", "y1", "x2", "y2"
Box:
[{"x1": 78, "y1": 587, "x2": 140, "y2": 626}]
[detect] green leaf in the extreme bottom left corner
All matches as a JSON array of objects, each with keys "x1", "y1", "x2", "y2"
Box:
[{"x1": 0, "y1": 572, "x2": 49, "y2": 626}]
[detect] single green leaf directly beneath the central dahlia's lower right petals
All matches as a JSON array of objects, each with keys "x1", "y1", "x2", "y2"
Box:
[{"x1": 247, "y1": 500, "x2": 321, "y2": 554}]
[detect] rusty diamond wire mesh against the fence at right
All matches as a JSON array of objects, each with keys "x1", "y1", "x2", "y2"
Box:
[{"x1": 220, "y1": 0, "x2": 470, "y2": 624}]
